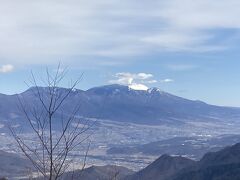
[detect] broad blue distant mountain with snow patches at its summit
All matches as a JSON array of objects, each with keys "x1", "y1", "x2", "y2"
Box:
[{"x1": 0, "y1": 85, "x2": 240, "y2": 124}]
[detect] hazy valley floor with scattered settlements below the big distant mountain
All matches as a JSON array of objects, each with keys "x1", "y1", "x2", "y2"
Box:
[{"x1": 0, "y1": 116, "x2": 240, "y2": 171}]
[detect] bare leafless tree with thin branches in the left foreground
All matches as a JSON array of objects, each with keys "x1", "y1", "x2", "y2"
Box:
[{"x1": 10, "y1": 65, "x2": 91, "y2": 180}]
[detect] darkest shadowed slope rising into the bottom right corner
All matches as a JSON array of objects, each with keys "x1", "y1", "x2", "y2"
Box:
[{"x1": 174, "y1": 143, "x2": 240, "y2": 180}]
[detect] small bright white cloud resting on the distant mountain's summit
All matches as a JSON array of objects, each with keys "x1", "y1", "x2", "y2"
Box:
[{"x1": 109, "y1": 72, "x2": 157, "y2": 90}]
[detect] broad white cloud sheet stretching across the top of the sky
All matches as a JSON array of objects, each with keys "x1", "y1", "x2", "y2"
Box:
[{"x1": 0, "y1": 0, "x2": 240, "y2": 65}]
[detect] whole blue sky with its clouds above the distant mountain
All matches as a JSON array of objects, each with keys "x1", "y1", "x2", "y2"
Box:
[{"x1": 0, "y1": 0, "x2": 240, "y2": 106}]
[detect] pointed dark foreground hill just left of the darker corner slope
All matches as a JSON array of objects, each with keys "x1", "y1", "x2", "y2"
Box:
[{"x1": 125, "y1": 155, "x2": 196, "y2": 180}]
